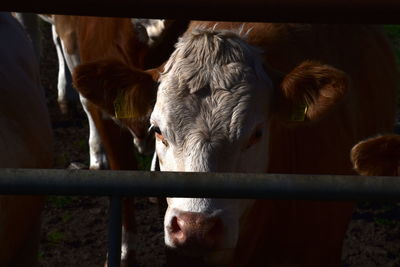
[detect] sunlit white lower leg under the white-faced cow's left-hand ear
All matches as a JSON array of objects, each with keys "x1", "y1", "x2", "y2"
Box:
[{"x1": 80, "y1": 95, "x2": 108, "y2": 170}]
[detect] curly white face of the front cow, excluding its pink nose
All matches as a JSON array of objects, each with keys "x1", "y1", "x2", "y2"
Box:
[{"x1": 151, "y1": 30, "x2": 272, "y2": 256}]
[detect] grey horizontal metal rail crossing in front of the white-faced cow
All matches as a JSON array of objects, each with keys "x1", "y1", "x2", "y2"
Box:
[{"x1": 0, "y1": 169, "x2": 400, "y2": 200}]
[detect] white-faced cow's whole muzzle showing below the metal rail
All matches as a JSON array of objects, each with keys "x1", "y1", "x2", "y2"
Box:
[{"x1": 164, "y1": 198, "x2": 253, "y2": 267}]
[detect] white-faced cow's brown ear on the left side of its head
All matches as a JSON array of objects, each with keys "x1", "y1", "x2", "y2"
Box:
[{"x1": 73, "y1": 60, "x2": 158, "y2": 119}]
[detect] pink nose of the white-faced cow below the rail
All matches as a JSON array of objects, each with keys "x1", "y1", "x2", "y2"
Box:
[{"x1": 167, "y1": 212, "x2": 223, "y2": 250}]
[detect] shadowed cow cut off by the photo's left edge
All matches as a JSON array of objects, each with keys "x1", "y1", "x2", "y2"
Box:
[{"x1": 0, "y1": 12, "x2": 53, "y2": 267}]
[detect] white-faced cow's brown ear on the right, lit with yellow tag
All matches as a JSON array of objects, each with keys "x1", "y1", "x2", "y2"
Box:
[{"x1": 271, "y1": 61, "x2": 349, "y2": 122}]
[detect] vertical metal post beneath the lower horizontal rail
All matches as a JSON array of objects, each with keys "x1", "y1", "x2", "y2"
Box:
[{"x1": 107, "y1": 196, "x2": 122, "y2": 267}]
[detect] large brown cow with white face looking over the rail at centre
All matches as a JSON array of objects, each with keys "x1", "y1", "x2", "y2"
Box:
[{"x1": 146, "y1": 22, "x2": 398, "y2": 267}]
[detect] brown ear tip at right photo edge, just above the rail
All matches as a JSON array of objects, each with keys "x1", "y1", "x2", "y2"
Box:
[{"x1": 350, "y1": 135, "x2": 400, "y2": 176}]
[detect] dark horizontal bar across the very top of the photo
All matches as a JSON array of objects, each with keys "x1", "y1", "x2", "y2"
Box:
[{"x1": 0, "y1": 0, "x2": 400, "y2": 23}]
